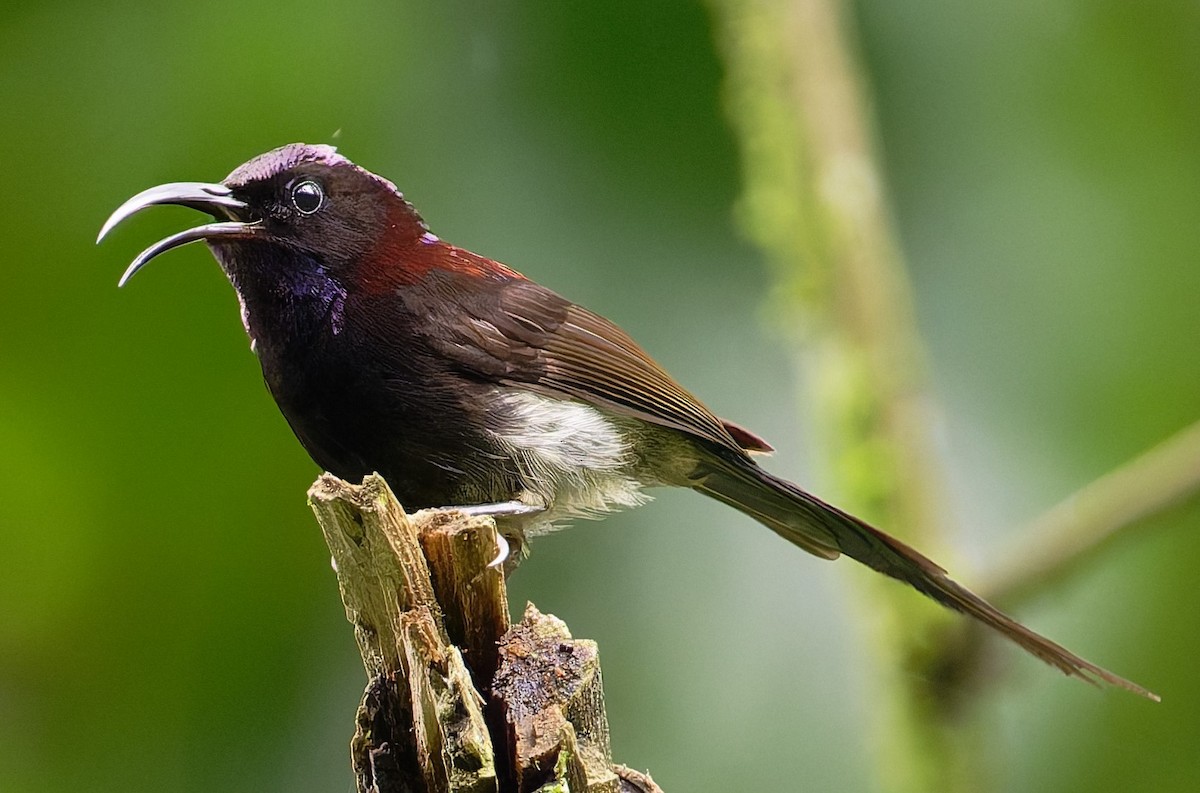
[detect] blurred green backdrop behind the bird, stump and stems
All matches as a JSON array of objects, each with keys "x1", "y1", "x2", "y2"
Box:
[{"x1": 0, "y1": 0, "x2": 1200, "y2": 793}]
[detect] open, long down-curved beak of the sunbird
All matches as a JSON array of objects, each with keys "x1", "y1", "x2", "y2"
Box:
[{"x1": 96, "y1": 181, "x2": 260, "y2": 287}]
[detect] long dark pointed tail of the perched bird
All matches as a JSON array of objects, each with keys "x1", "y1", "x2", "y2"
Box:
[{"x1": 694, "y1": 459, "x2": 1159, "y2": 702}]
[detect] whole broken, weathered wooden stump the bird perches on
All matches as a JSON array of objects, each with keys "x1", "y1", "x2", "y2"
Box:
[{"x1": 308, "y1": 474, "x2": 661, "y2": 793}]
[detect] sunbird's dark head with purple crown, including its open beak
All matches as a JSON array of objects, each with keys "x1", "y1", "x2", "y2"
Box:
[{"x1": 97, "y1": 143, "x2": 427, "y2": 286}]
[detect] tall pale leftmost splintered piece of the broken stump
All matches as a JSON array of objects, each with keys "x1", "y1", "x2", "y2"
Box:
[{"x1": 308, "y1": 474, "x2": 498, "y2": 793}]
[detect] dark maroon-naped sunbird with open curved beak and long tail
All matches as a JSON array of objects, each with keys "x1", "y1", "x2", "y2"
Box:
[{"x1": 97, "y1": 143, "x2": 1158, "y2": 699}]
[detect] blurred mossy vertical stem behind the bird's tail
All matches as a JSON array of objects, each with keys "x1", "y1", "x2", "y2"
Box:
[{"x1": 713, "y1": 0, "x2": 978, "y2": 791}]
